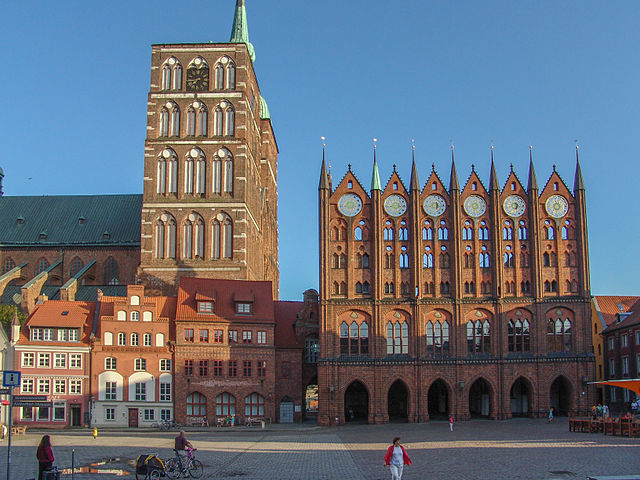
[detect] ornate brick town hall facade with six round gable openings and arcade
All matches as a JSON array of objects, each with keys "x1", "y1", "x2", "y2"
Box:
[{"x1": 318, "y1": 146, "x2": 594, "y2": 425}]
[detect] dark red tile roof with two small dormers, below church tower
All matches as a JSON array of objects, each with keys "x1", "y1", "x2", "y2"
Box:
[{"x1": 176, "y1": 277, "x2": 274, "y2": 322}]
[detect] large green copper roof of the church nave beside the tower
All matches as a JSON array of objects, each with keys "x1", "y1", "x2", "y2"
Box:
[{"x1": 0, "y1": 195, "x2": 142, "y2": 247}]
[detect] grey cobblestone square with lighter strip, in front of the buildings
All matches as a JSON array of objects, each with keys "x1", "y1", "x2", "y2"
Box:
[{"x1": 0, "y1": 419, "x2": 640, "y2": 480}]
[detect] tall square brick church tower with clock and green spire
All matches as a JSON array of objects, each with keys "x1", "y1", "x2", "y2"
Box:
[{"x1": 138, "y1": 0, "x2": 279, "y2": 298}]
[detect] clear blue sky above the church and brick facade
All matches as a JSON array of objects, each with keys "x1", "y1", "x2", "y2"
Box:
[{"x1": 0, "y1": 0, "x2": 640, "y2": 300}]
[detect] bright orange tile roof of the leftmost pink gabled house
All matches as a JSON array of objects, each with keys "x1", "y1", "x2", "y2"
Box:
[{"x1": 20, "y1": 300, "x2": 96, "y2": 344}]
